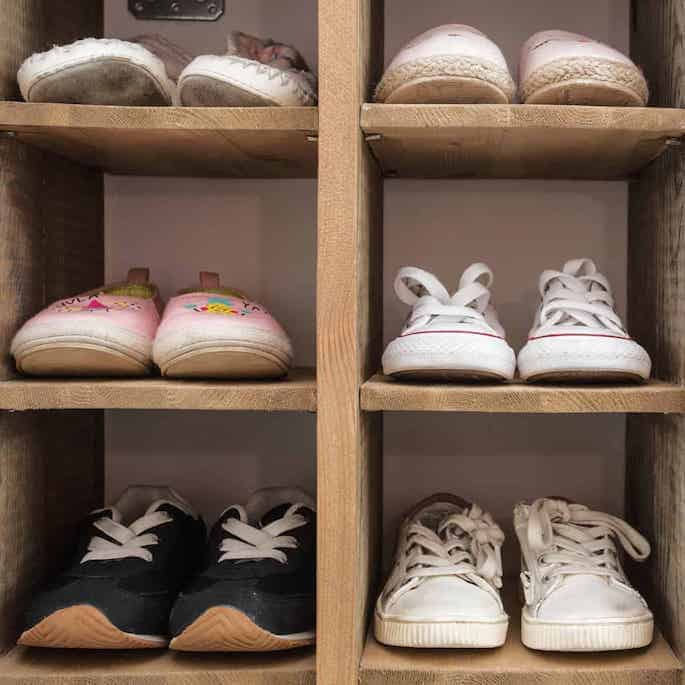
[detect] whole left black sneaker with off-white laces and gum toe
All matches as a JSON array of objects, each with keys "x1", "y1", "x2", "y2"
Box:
[{"x1": 19, "y1": 486, "x2": 205, "y2": 649}]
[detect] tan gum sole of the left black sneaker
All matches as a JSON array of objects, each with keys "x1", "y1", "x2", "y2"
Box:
[{"x1": 18, "y1": 604, "x2": 168, "y2": 649}]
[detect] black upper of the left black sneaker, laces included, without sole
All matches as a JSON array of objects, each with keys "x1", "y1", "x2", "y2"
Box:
[{"x1": 25, "y1": 486, "x2": 205, "y2": 636}]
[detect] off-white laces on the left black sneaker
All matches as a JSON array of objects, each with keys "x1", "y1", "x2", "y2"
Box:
[{"x1": 81, "y1": 511, "x2": 174, "y2": 564}]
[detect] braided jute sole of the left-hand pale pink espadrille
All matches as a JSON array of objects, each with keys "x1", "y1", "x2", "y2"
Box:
[{"x1": 376, "y1": 55, "x2": 516, "y2": 104}]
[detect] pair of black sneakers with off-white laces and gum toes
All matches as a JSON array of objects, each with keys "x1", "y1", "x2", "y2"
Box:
[{"x1": 19, "y1": 486, "x2": 316, "y2": 652}]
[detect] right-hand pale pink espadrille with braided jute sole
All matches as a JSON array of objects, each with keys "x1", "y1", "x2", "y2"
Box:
[{"x1": 519, "y1": 31, "x2": 649, "y2": 107}]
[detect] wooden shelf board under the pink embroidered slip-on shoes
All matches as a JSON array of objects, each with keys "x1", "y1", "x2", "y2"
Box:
[{"x1": 0, "y1": 369, "x2": 316, "y2": 411}]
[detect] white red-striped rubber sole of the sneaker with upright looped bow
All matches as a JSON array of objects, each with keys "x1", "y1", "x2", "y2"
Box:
[{"x1": 383, "y1": 331, "x2": 516, "y2": 381}]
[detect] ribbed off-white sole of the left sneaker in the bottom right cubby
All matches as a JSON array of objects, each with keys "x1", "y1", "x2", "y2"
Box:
[{"x1": 374, "y1": 614, "x2": 509, "y2": 649}]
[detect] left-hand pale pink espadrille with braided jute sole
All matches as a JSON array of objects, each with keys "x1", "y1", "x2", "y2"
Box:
[{"x1": 376, "y1": 24, "x2": 516, "y2": 104}]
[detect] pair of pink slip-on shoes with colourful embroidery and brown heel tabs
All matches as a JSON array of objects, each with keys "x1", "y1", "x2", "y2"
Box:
[{"x1": 10, "y1": 269, "x2": 293, "y2": 378}]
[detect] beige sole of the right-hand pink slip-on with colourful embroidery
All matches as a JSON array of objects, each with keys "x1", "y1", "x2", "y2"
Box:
[{"x1": 160, "y1": 346, "x2": 288, "y2": 379}]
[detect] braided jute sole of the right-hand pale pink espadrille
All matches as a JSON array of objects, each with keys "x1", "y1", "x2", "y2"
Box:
[{"x1": 521, "y1": 58, "x2": 649, "y2": 107}]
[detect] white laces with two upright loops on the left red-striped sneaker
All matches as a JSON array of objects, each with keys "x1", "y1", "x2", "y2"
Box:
[{"x1": 395, "y1": 262, "x2": 502, "y2": 335}]
